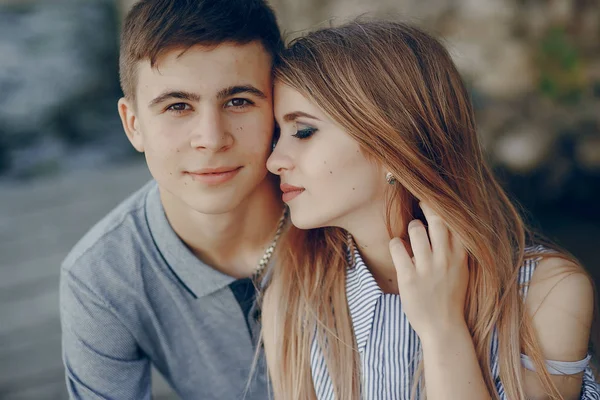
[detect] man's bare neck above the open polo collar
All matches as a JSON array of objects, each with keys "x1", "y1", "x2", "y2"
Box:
[{"x1": 161, "y1": 177, "x2": 283, "y2": 278}]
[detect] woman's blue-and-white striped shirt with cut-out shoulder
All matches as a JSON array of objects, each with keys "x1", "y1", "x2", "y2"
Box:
[{"x1": 311, "y1": 245, "x2": 600, "y2": 400}]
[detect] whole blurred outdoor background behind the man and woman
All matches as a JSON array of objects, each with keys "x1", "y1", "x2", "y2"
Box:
[{"x1": 0, "y1": 0, "x2": 600, "y2": 399}]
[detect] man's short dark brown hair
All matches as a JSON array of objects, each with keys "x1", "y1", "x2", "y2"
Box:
[{"x1": 119, "y1": 0, "x2": 283, "y2": 100}]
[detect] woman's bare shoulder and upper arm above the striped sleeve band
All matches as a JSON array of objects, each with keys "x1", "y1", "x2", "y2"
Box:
[{"x1": 525, "y1": 249, "x2": 594, "y2": 361}]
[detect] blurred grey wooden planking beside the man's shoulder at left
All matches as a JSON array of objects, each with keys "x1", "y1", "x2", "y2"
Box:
[{"x1": 0, "y1": 162, "x2": 177, "y2": 400}]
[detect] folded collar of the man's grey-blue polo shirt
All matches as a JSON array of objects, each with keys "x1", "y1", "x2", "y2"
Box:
[{"x1": 146, "y1": 182, "x2": 235, "y2": 298}]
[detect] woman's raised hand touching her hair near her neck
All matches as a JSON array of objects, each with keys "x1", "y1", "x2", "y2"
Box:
[{"x1": 390, "y1": 203, "x2": 469, "y2": 342}]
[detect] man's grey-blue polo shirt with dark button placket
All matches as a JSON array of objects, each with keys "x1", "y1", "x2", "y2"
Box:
[{"x1": 60, "y1": 182, "x2": 268, "y2": 400}]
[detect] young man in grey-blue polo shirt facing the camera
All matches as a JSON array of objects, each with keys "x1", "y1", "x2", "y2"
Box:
[{"x1": 60, "y1": 0, "x2": 284, "y2": 400}]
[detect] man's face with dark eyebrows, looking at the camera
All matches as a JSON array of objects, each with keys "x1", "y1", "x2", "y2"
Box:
[{"x1": 119, "y1": 43, "x2": 273, "y2": 214}]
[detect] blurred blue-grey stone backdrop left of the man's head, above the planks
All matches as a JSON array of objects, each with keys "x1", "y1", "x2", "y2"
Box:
[{"x1": 0, "y1": 0, "x2": 129, "y2": 178}]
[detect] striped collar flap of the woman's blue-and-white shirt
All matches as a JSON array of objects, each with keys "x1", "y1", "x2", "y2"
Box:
[{"x1": 346, "y1": 241, "x2": 383, "y2": 351}]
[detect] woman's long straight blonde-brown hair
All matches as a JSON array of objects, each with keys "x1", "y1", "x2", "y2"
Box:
[{"x1": 262, "y1": 21, "x2": 592, "y2": 400}]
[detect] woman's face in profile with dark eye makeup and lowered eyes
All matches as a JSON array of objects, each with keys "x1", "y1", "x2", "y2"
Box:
[{"x1": 267, "y1": 82, "x2": 386, "y2": 229}]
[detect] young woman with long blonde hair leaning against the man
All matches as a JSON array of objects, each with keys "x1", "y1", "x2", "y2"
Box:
[{"x1": 262, "y1": 21, "x2": 600, "y2": 400}]
